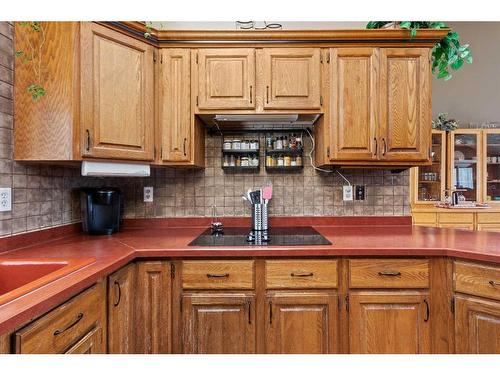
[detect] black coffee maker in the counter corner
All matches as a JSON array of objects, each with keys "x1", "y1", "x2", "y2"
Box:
[{"x1": 80, "y1": 187, "x2": 123, "y2": 234}]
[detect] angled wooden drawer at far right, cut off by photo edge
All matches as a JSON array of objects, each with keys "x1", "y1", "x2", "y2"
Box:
[{"x1": 454, "y1": 262, "x2": 500, "y2": 300}]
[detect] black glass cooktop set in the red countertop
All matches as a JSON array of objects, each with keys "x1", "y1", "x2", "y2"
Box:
[{"x1": 188, "y1": 227, "x2": 332, "y2": 246}]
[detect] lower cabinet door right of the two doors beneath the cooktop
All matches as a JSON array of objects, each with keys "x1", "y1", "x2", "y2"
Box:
[{"x1": 349, "y1": 292, "x2": 430, "y2": 354}]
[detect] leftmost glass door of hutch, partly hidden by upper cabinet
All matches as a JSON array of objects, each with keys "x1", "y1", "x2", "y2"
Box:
[{"x1": 416, "y1": 131, "x2": 446, "y2": 202}]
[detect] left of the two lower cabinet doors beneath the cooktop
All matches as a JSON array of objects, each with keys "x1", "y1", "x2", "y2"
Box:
[{"x1": 182, "y1": 292, "x2": 255, "y2": 354}]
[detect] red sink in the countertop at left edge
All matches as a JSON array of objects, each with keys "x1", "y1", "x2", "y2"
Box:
[{"x1": 0, "y1": 258, "x2": 95, "y2": 305}]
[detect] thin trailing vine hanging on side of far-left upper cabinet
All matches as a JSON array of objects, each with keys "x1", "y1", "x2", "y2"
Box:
[{"x1": 15, "y1": 21, "x2": 46, "y2": 101}]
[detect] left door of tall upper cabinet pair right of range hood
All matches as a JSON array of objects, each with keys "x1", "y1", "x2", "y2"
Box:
[{"x1": 330, "y1": 48, "x2": 379, "y2": 161}]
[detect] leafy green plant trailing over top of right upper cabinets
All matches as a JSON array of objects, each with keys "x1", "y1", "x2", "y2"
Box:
[{"x1": 366, "y1": 21, "x2": 473, "y2": 81}]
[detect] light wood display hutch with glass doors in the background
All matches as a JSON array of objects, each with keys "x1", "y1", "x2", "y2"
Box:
[{"x1": 410, "y1": 129, "x2": 500, "y2": 231}]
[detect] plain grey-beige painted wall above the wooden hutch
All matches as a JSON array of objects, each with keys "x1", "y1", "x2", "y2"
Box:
[{"x1": 432, "y1": 22, "x2": 500, "y2": 124}]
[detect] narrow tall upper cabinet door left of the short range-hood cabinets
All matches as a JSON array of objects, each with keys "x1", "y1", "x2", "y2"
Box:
[{"x1": 159, "y1": 49, "x2": 193, "y2": 162}]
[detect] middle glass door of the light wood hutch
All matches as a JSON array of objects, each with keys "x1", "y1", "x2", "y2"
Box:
[{"x1": 451, "y1": 130, "x2": 480, "y2": 201}]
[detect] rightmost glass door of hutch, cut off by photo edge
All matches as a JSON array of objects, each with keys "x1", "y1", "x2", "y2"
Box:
[{"x1": 484, "y1": 131, "x2": 500, "y2": 203}]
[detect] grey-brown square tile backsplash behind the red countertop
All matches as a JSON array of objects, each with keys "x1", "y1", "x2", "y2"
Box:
[{"x1": 0, "y1": 22, "x2": 410, "y2": 236}]
